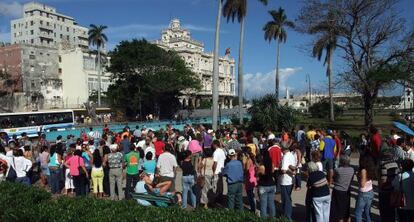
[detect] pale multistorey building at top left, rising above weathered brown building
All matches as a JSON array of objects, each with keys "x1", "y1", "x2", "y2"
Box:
[{"x1": 11, "y1": 2, "x2": 88, "y2": 49}]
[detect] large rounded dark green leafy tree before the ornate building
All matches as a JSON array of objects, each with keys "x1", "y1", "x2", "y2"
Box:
[{"x1": 106, "y1": 39, "x2": 200, "y2": 119}]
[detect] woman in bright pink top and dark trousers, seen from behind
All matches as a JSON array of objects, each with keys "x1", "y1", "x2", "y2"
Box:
[{"x1": 65, "y1": 150, "x2": 89, "y2": 196}]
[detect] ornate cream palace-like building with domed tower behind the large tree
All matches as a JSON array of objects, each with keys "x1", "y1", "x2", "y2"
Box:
[{"x1": 155, "y1": 19, "x2": 236, "y2": 108}]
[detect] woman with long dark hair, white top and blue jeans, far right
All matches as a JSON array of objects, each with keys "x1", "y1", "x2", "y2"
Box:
[{"x1": 355, "y1": 155, "x2": 376, "y2": 222}]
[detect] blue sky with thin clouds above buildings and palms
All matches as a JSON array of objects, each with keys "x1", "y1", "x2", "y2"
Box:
[{"x1": 0, "y1": 0, "x2": 414, "y2": 98}]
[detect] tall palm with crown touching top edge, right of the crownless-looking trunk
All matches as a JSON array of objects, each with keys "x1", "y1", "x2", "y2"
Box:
[{"x1": 223, "y1": 0, "x2": 268, "y2": 124}]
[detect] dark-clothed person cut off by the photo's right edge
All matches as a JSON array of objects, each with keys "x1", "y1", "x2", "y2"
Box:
[{"x1": 392, "y1": 159, "x2": 414, "y2": 210}]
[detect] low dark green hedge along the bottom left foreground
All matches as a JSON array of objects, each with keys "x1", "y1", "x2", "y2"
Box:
[{"x1": 0, "y1": 182, "x2": 281, "y2": 222}]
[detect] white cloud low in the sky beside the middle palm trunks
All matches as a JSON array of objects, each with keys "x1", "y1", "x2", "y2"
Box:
[{"x1": 244, "y1": 67, "x2": 302, "y2": 98}]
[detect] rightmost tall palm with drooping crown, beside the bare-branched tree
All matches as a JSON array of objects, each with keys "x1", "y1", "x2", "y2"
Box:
[{"x1": 309, "y1": 12, "x2": 345, "y2": 122}]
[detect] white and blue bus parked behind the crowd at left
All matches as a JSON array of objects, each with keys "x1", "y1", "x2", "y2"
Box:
[{"x1": 0, "y1": 110, "x2": 75, "y2": 137}]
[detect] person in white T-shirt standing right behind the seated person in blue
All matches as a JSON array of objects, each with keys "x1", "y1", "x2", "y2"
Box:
[{"x1": 157, "y1": 145, "x2": 178, "y2": 191}]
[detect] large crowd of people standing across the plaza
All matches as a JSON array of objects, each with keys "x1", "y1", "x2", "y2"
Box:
[{"x1": 0, "y1": 125, "x2": 414, "y2": 222}]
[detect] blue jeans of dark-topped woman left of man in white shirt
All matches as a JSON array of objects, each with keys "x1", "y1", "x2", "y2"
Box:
[{"x1": 259, "y1": 186, "x2": 276, "y2": 217}]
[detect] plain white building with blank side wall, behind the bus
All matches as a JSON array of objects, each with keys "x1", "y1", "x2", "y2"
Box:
[{"x1": 59, "y1": 48, "x2": 111, "y2": 108}]
